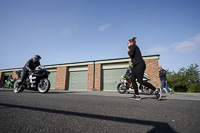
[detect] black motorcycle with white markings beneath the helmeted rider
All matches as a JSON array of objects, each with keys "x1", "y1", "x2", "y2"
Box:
[{"x1": 14, "y1": 66, "x2": 51, "y2": 93}]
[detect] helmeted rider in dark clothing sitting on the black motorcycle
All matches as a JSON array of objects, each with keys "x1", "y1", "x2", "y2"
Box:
[{"x1": 18, "y1": 55, "x2": 41, "y2": 90}]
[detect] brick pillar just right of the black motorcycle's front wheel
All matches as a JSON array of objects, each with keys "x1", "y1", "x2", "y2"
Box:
[{"x1": 55, "y1": 67, "x2": 68, "y2": 90}]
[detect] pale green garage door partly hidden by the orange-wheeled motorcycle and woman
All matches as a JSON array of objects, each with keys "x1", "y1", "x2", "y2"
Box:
[{"x1": 102, "y1": 68, "x2": 127, "y2": 91}]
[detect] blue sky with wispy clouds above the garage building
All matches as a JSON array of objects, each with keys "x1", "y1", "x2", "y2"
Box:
[{"x1": 0, "y1": 0, "x2": 200, "y2": 71}]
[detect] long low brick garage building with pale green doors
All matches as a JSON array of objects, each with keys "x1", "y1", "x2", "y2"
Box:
[{"x1": 0, "y1": 55, "x2": 160, "y2": 91}]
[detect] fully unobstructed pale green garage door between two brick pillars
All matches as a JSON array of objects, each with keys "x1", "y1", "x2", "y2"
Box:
[{"x1": 69, "y1": 71, "x2": 88, "y2": 91}]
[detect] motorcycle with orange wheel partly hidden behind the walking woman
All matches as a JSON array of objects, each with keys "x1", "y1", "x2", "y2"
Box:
[{"x1": 117, "y1": 73, "x2": 153, "y2": 95}]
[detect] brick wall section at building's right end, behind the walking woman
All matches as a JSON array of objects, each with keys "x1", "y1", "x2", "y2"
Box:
[{"x1": 144, "y1": 59, "x2": 160, "y2": 88}]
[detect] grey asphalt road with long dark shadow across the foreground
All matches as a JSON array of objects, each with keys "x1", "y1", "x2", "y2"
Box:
[{"x1": 0, "y1": 88, "x2": 200, "y2": 133}]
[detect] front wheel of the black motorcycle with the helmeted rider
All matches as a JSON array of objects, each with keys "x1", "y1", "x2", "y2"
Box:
[{"x1": 38, "y1": 79, "x2": 51, "y2": 93}]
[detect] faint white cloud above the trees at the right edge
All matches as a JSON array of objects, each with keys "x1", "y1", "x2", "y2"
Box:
[{"x1": 173, "y1": 34, "x2": 200, "y2": 53}]
